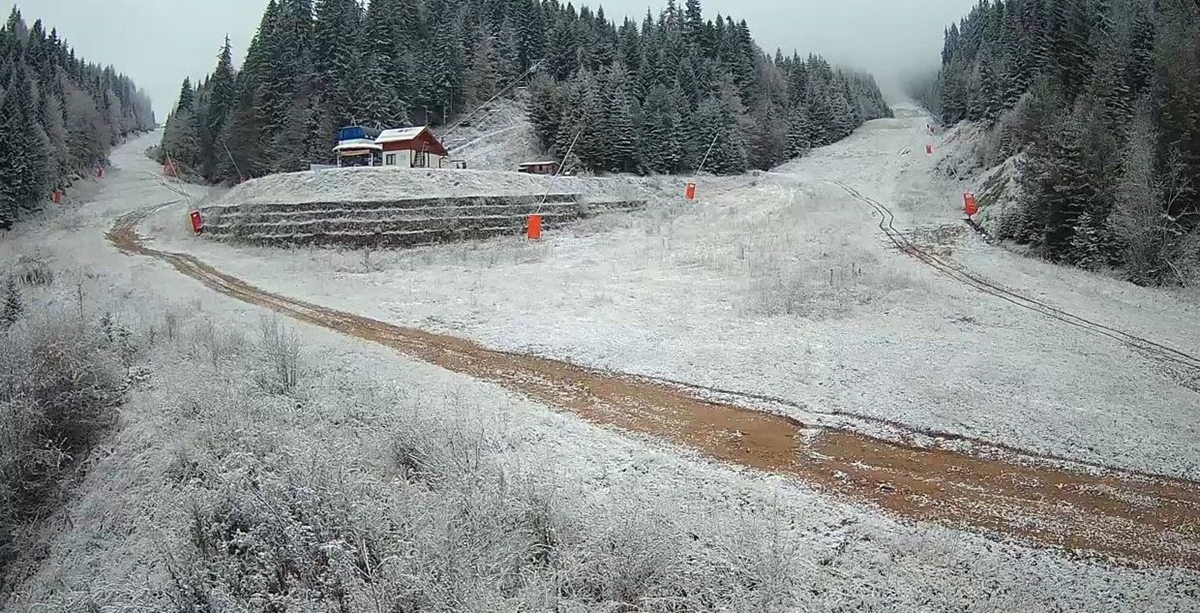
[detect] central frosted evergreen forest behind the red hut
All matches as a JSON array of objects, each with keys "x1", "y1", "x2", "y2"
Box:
[{"x1": 163, "y1": 0, "x2": 890, "y2": 181}]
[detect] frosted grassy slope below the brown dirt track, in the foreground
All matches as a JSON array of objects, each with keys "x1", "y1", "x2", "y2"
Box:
[{"x1": 2, "y1": 260, "x2": 1183, "y2": 613}]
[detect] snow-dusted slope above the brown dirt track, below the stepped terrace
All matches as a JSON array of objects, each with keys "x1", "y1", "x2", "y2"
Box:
[{"x1": 148, "y1": 109, "x2": 1200, "y2": 477}]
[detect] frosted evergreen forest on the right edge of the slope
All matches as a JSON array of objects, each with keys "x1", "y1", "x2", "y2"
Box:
[{"x1": 918, "y1": 0, "x2": 1200, "y2": 284}]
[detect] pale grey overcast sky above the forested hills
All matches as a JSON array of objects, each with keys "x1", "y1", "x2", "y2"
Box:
[{"x1": 7, "y1": 0, "x2": 976, "y2": 121}]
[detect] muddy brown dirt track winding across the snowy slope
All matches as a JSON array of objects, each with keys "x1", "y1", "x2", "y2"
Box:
[{"x1": 108, "y1": 208, "x2": 1200, "y2": 570}]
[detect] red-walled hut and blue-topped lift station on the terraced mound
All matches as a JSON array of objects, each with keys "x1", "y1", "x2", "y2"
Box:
[{"x1": 334, "y1": 126, "x2": 460, "y2": 168}]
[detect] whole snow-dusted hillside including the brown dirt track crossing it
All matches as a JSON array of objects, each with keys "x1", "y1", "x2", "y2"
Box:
[{"x1": 0, "y1": 105, "x2": 1200, "y2": 613}]
